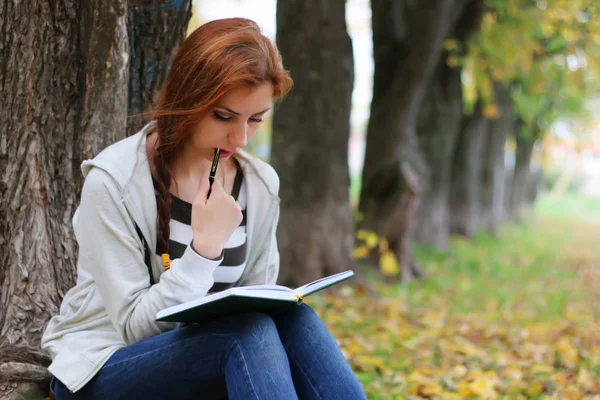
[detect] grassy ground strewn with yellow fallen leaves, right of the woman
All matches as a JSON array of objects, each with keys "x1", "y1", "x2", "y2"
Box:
[{"x1": 309, "y1": 194, "x2": 600, "y2": 400}]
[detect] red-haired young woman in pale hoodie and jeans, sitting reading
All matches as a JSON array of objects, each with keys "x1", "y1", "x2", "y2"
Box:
[{"x1": 42, "y1": 18, "x2": 365, "y2": 400}]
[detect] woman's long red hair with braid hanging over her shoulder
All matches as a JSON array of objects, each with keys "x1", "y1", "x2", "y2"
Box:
[{"x1": 152, "y1": 18, "x2": 293, "y2": 253}]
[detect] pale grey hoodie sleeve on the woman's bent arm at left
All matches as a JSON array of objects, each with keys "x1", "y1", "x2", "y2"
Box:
[{"x1": 73, "y1": 168, "x2": 222, "y2": 344}]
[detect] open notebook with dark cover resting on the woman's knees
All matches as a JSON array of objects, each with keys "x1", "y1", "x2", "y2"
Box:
[{"x1": 156, "y1": 271, "x2": 354, "y2": 323}]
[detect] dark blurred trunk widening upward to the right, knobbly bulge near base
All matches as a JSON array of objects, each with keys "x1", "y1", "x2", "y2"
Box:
[{"x1": 360, "y1": 0, "x2": 468, "y2": 280}]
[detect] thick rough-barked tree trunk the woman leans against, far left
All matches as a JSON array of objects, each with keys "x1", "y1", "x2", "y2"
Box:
[{"x1": 0, "y1": 0, "x2": 128, "y2": 395}]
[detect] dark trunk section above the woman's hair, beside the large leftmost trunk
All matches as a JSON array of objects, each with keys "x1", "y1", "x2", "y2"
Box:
[{"x1": 127, "y1": 0, "x2": 192, "y2": 135}]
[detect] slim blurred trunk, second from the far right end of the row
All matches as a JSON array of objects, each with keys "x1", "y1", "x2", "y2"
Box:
[{"x1": 481, "y1": 83, "x2": 515, "y2": 235}]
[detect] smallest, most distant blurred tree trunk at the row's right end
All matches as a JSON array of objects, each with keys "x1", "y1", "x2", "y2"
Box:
[{"x1": 509, "y1": 132, "x2": 535, "y2": 221}]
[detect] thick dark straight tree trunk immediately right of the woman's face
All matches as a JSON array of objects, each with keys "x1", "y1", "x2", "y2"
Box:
[{"x1": 271, "y1": 0, "x2": 354, "y2": 285}]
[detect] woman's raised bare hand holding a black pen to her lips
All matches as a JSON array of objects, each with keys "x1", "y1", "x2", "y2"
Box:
[{"x1": 192, "y1": 177, "x2": 243, "y2": 259}]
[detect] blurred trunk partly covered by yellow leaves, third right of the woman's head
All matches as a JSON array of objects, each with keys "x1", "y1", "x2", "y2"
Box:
[{"x1": 415, "y1": 0, "x2": 484, "y2": 250}]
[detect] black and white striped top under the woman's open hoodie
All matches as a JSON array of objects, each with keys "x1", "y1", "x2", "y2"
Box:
[{"x1": 154, "y1": 167, "x2": 247, "y2": 293}]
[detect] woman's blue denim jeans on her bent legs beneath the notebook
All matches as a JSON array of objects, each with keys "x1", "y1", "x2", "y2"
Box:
[{"x1": 51, "y1": 304, "x2": 366, "y2": 400}]
